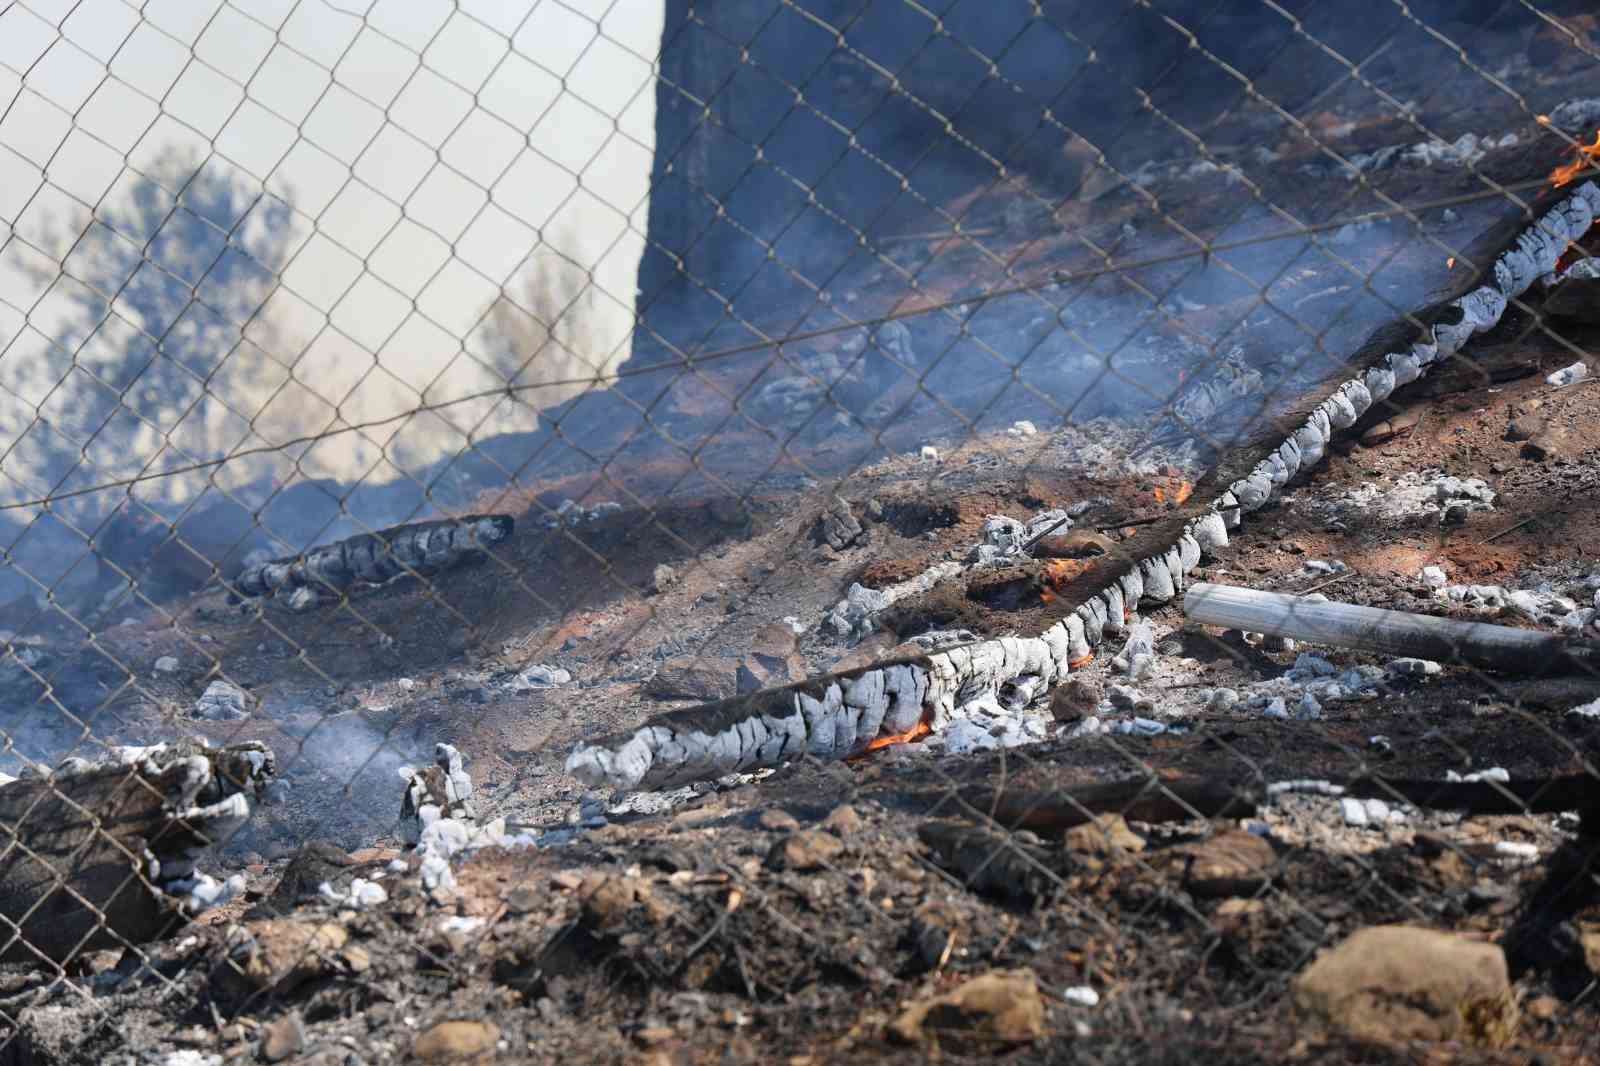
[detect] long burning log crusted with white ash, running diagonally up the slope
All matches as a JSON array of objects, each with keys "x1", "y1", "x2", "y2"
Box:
[{"x1": 566, "y1": 182, "x2": 1600, "y2": 789}]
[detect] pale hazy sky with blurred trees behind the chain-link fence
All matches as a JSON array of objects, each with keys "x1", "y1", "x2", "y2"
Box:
[{"x1": 0, "y1": 0, "x2": 662, "y2": 512}]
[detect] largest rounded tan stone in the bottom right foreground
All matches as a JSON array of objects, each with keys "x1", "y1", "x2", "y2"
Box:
[{"x1": 1293, "y1": 925, "x2": 1512, "y2": 1044}]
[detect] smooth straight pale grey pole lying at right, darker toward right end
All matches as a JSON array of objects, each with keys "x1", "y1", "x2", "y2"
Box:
[{"x1": 1184, "y1": 583, "x2": 1600, "y2": 674}]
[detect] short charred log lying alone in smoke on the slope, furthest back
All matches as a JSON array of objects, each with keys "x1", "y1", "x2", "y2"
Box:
[{"x1": 234, "y1": 514, "x2": 515, "y2": 595}]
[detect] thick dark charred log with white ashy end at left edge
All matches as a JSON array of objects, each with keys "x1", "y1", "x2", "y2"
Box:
[{"x1": 0, "y1": 741, "x2": 275, "y2": 964}]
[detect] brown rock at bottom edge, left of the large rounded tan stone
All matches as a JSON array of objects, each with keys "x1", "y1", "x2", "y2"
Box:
[{"x1": 890, "y1": 970, "x2": 1045, "y2": 1050}]
